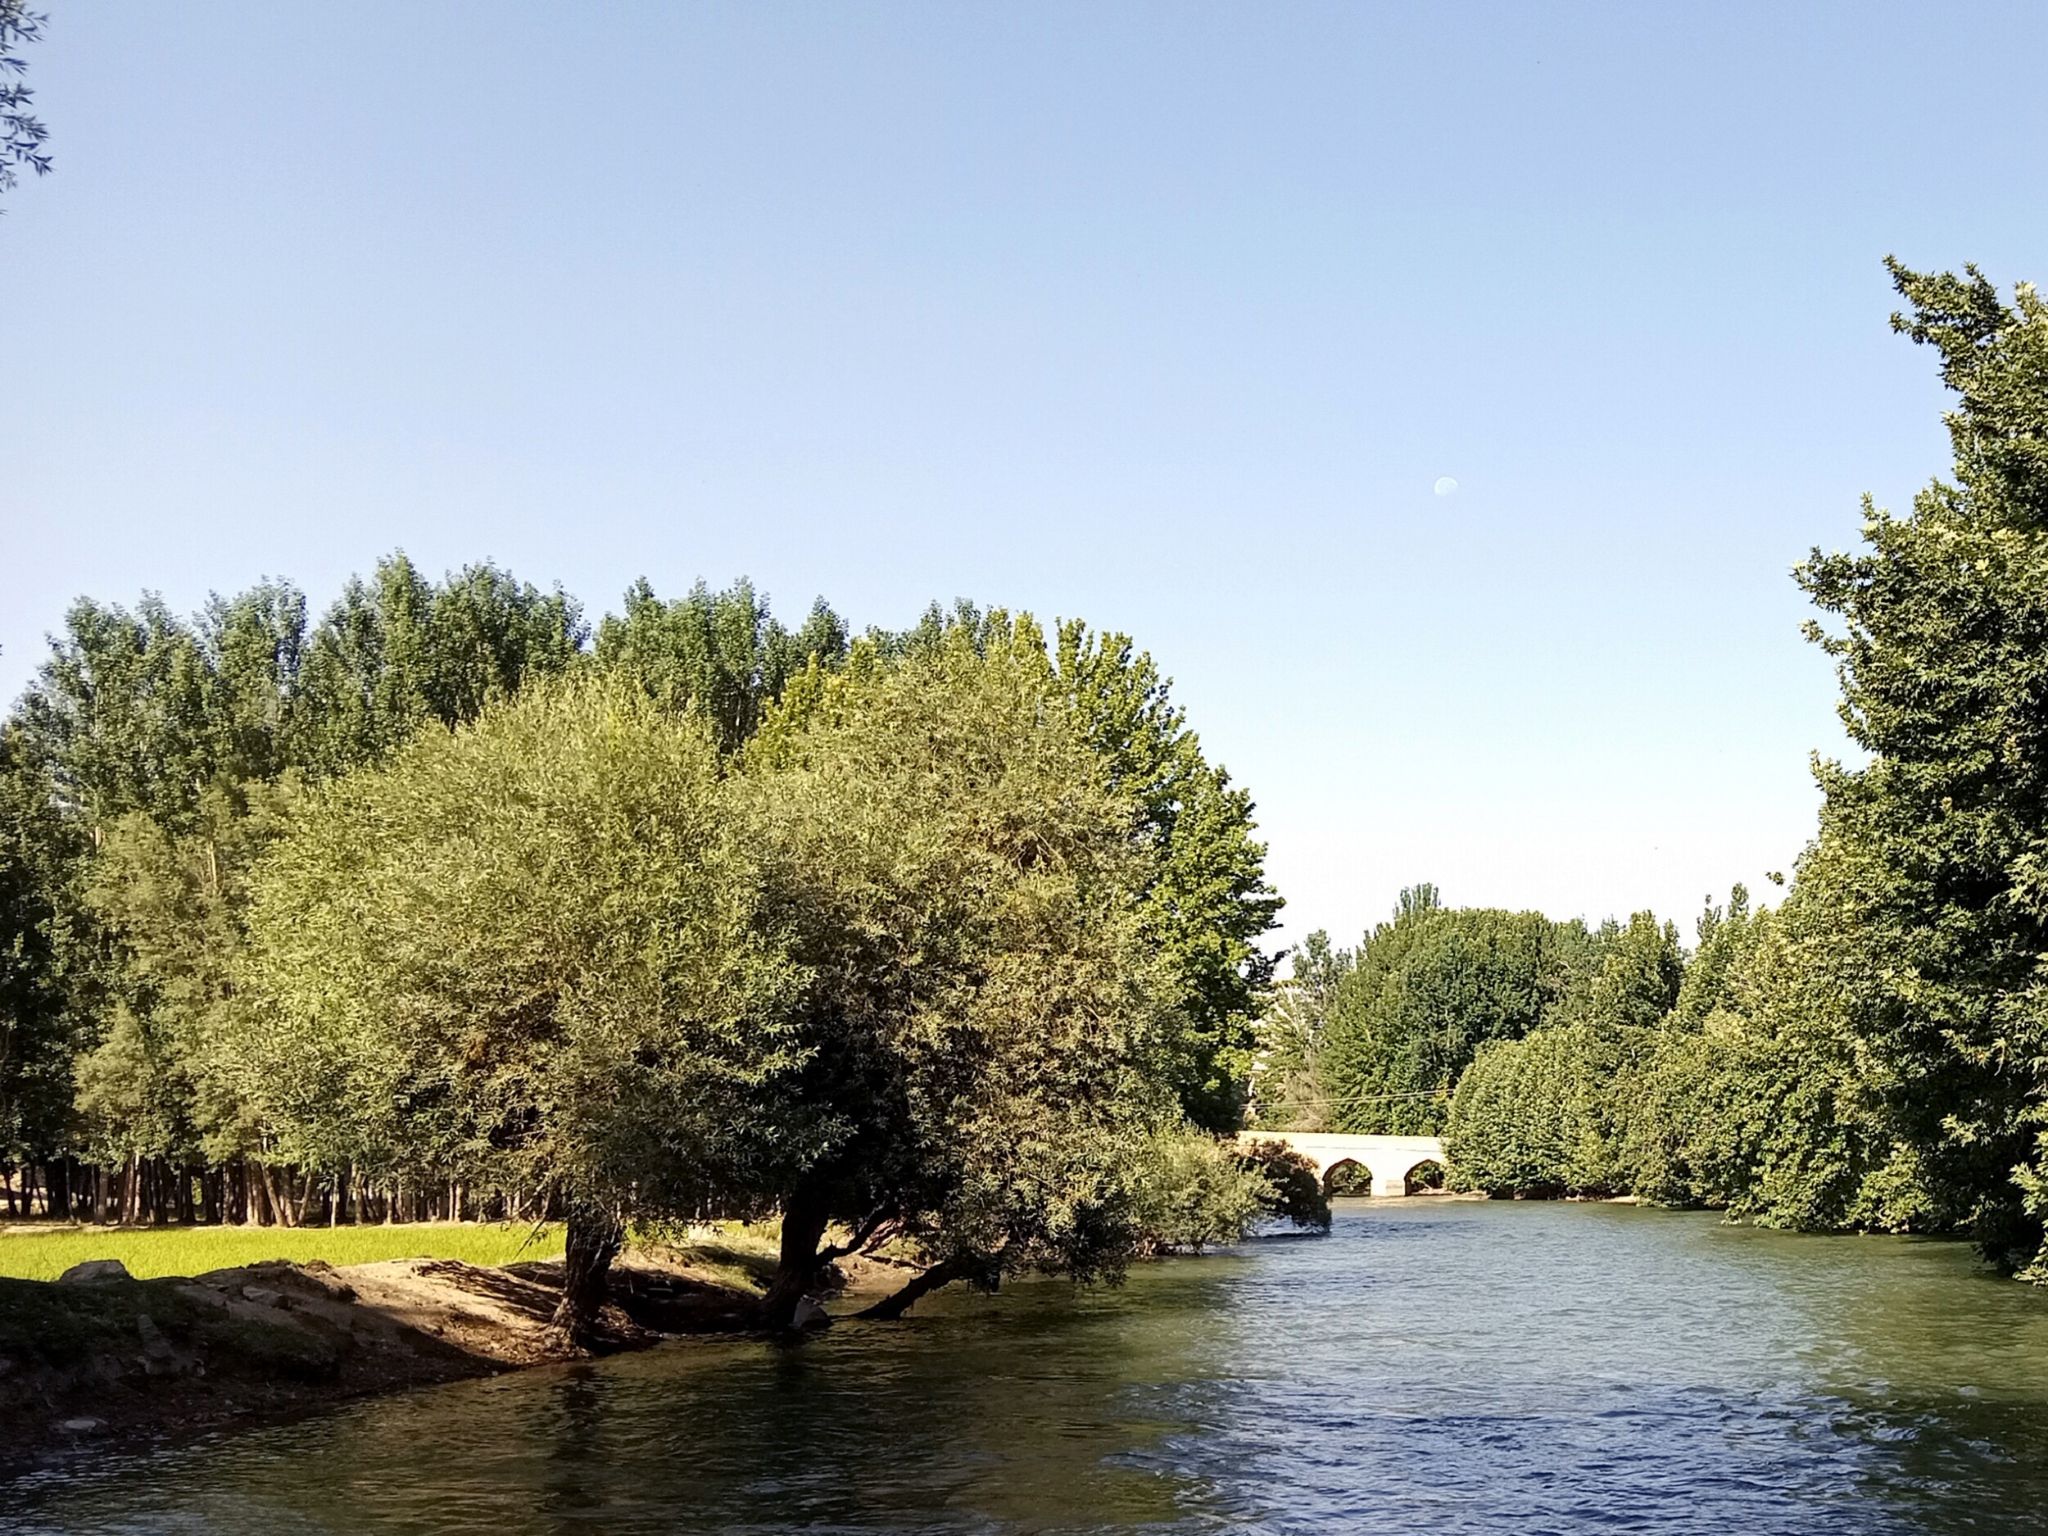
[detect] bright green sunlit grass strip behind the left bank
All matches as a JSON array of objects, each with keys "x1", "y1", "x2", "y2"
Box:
[{"x1": 0, "y1": 1223, "x2": 561, "y2": 1280}]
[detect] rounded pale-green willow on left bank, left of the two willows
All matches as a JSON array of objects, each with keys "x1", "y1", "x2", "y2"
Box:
[{"x1": 233, "y1": 680, "x2": 805, "y2": 1341}]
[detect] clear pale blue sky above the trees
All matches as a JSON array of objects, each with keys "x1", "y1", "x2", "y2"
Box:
[{"x1": 0, "y1": 0, "x2": 2048, "y2": 958}]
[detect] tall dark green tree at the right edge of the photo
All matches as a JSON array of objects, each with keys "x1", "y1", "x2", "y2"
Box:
[{"x1": 1798, "y1": 262, "x2": 2048, "y2": 1264}]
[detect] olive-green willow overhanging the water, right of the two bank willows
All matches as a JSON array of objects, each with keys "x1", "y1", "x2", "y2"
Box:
[{"x1": 741, "y1": 621, "x2": 1180, "y2": 1321}]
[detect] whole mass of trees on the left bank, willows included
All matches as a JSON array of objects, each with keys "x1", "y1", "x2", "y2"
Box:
[{"x1": 0, "y1": 555, "x2": 1284, "y2": 1335}]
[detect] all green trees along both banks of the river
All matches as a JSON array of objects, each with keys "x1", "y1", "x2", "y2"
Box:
[{"x1": 0, "y1": 256, "x2": 2048, "y2": 1384}]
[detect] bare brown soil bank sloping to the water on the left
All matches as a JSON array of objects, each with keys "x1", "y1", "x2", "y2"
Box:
[{"x1": 0, "y1": 1245, "x2": 899, "y2": 1473}]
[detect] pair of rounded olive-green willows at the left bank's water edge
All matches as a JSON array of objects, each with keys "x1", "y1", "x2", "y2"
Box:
[{"x1": 215, "y1": 616, "x2": 1268, "y2": 1337}]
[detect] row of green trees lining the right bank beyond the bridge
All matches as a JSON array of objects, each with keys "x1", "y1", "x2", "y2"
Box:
[{"x1": 1262, "y1": 264, "x2": 2048, "y2": 1278}]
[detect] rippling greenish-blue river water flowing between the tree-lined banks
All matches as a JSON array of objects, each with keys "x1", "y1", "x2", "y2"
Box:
[{"x1": 0, "y1": 1200, "x2": 2048, "y2": 1536}]
